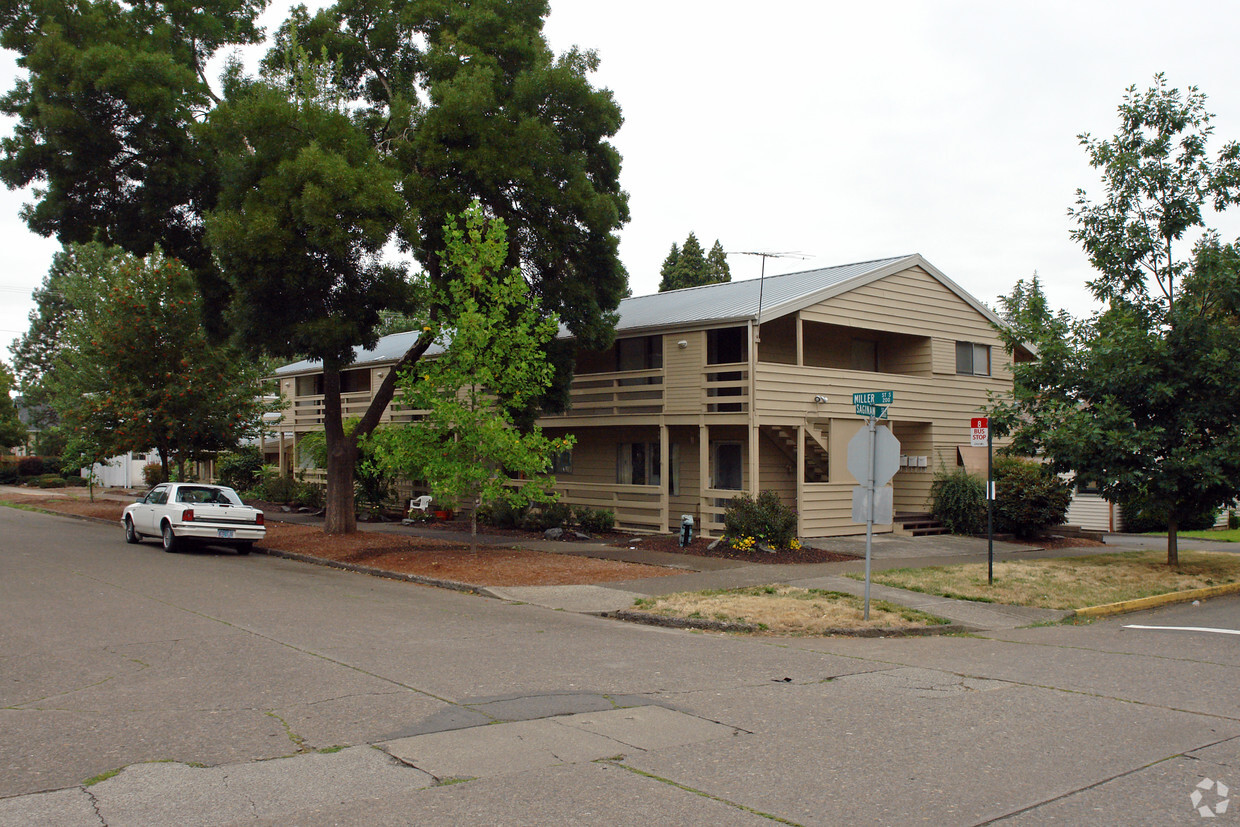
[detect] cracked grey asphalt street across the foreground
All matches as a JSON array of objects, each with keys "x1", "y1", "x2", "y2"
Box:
[{"x1": 0, "y1": 508, "x2": 1240, "y2": 826}]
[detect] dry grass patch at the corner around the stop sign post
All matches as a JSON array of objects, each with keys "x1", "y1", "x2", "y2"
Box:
[{"x1": 635, "y1": 585, "x2": 947, "y2": 635}]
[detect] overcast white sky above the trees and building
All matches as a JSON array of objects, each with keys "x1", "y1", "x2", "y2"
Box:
[{"x1": 0, "y1": 0, "x2": 1240, "y2": 360}]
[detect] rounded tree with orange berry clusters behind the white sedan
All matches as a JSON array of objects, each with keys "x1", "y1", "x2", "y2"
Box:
[{"x1": 40, "y1": 248, "x2": 267, "y2": 481}]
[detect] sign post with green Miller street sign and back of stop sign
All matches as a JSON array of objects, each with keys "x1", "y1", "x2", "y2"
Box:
[{"x1": 848, "y1": 391, "x2": 900, "y2": 620}]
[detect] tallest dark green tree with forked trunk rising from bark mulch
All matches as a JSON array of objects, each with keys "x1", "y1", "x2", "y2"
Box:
[{"x1": 208, "y1": 0, "x2": 629, "y2": 532}]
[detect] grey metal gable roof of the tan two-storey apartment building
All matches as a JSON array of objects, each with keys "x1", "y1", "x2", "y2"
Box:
[{"x1": 275, "y1": 254, "x2": 1002, "y2": 376}]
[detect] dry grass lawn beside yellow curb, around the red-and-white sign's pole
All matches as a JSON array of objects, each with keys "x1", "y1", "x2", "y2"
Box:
[{"x1": 848, "y1": 551, "x2": 1240, "y2": 609}]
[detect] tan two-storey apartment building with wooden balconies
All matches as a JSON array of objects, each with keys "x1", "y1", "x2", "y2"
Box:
[{"x1": 266, "y1": 255, "x2": 1028, "y2": 537}]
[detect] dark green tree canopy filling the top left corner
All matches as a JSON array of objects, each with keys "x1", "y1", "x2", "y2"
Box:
[{"x1": 0, "y1": 0, "x2": 265, "y2": 301}]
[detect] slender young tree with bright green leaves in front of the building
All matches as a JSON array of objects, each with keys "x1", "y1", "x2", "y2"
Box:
[{"x1": 372, "y1": 202, "x2": 573, "y2": 549}]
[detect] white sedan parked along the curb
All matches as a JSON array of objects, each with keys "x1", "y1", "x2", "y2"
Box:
[{"x1": 120, "y1": 482, "x2": 267, "y2": 554}]
